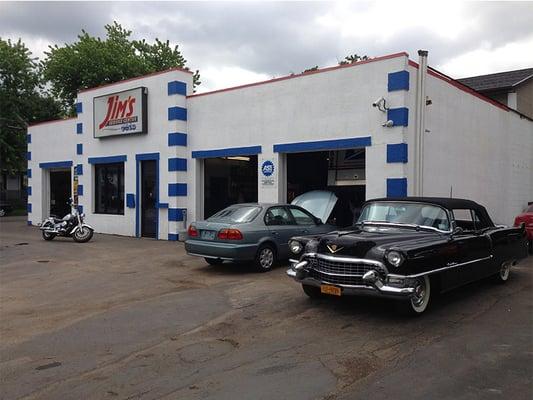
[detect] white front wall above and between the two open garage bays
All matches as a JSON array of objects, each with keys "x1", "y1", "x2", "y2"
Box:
[{"x1": 188, "y1": 55, "x2": 408, "y2": 222}]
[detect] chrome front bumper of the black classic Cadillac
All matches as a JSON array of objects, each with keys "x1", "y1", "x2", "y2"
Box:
[{"x1": 287, "y1": 260, "x2": 415, "y2": 298}]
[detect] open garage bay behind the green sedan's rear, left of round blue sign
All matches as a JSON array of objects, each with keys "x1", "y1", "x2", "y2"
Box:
[{"x1": 204, "y1": 155, "x2": 257, "y2": 218}]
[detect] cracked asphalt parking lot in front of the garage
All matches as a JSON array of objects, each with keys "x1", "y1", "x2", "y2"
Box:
[{"x1": 0, "y1": 217, "x2": 533, "y2": 400}]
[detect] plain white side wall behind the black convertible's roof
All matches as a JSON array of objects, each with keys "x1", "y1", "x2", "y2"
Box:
[{"x1": 409, "y1": 67, "x2": 533, "y2": 225}]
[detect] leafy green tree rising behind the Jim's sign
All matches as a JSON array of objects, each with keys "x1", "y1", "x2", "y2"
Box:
[{"x1": 42, "y1": 22, "x2": 201, "y2": 114}]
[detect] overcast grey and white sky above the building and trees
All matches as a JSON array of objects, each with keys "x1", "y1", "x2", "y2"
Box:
[{"x1": 0, "y1": 0, "x2": 533, "y2": 92}]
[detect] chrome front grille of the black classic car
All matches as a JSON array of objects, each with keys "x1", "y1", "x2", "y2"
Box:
[{"x1": 307, "y1": 254, "x2": 387, "y2": 285}]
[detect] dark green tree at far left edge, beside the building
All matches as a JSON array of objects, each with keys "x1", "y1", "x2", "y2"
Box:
[{"x1": 0, "y1": 38, "x2": 61, "y2": 173}]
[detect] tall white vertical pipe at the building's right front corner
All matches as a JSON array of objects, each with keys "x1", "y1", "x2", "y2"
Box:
[{"x1": 414, "y1": 50, "x2": 428, "y2": 196}]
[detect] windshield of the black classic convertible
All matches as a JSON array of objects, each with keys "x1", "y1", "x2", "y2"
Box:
[{"x1": 357, "y1": 202, "x2": 450, "y2": 231}]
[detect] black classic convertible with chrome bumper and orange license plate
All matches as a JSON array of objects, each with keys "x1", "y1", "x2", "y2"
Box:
[{"x1": 287, "y1": 197, "x2": 527, "y2": 314}]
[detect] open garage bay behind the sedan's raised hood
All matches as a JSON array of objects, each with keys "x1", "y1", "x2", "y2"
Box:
[{"x1": 287, "y1": 147, "x2": 366, "y2": 227}]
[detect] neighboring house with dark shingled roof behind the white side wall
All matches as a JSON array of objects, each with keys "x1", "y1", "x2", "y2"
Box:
[{"x1": 458, "y1": 68, "x2": 533, "y2": 118}]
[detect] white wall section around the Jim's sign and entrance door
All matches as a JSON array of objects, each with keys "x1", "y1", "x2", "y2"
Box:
[{"x1": 28, "y1": 70, "x2": 192, "y2": 239}]
